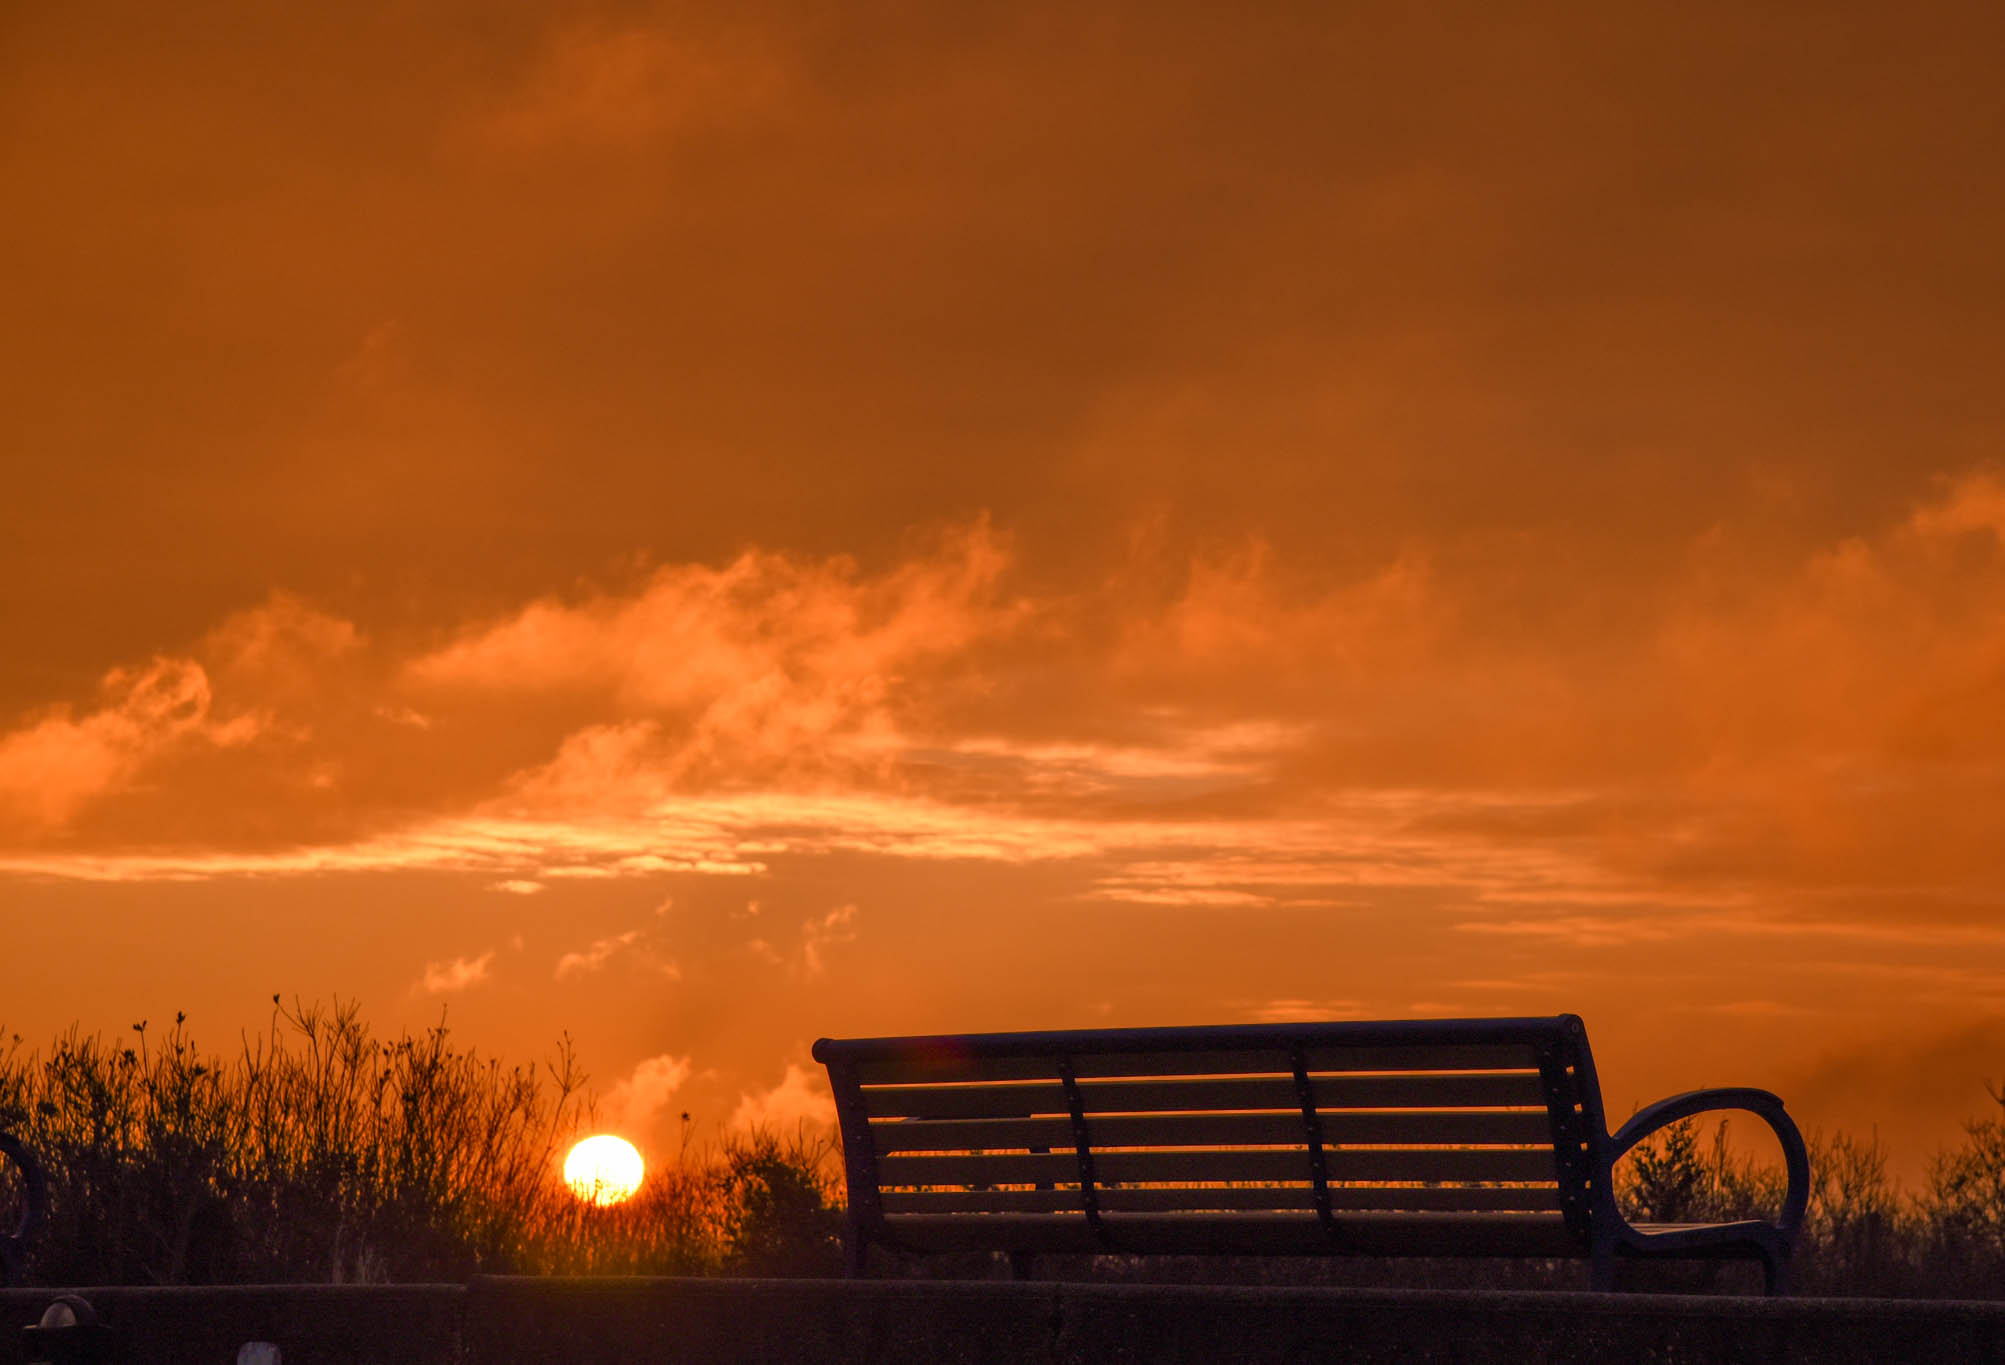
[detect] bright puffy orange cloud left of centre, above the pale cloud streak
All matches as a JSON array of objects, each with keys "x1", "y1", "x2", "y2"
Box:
[{"x1": 409, "y1": 521, "x2": 1025, "y2": 806}]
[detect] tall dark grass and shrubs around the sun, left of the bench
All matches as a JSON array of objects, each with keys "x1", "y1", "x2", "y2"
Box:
[{"x1": 0, "y1": 998, "x2": 840, "y2": 1285}]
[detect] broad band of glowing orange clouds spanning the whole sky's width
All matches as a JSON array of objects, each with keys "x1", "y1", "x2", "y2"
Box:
[{"x1": 0, "y1": 471, "x2": 2005, "y2": 958}]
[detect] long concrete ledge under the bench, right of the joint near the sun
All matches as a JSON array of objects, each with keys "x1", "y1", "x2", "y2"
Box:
[{"x1": 467, "y1": 1279, "x2": 2005, "y2": 1365}]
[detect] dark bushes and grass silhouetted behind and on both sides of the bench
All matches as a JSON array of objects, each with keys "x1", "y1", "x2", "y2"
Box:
[{"x1": 11, "y1": 998, "x2": 2005, "y2": 1299}]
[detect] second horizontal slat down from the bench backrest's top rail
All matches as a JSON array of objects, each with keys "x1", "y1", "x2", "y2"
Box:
[{"x1": 862, "y1": 1070, "x2": 1546, "y2": 1118}]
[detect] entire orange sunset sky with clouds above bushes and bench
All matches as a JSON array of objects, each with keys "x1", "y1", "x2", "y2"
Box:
[{"x1": 0, "y1": 0, "x2": 2005, "y2": 1177}]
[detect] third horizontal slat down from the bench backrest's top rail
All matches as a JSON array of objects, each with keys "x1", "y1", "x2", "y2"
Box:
[{"x1": 870, "y1": 1110, "x2": 1552, "y2": 1153}]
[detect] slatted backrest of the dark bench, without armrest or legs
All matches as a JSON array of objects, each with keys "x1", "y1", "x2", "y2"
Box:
[{"x1": 814, "y1": 1014, "x2": 1604, "y2": 1249}]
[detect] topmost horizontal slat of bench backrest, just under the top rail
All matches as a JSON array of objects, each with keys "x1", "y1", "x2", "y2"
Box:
[{"x1": 852, "y1": 1044, "x2": 1538, "y2": 1084}]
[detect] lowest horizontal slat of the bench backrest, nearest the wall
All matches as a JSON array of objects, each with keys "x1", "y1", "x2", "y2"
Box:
[{"x1": 886, "y1": 1213, "x2": 1584, "y2": 1257}]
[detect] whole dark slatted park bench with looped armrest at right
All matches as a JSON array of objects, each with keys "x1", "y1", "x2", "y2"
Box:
[{"x1": 814, "y1": 1014, "x2": 1811, "y2": 1293}]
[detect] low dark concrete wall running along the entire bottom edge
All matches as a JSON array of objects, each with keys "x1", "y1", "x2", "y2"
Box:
[{"x1": 0, "y1": 1279, "x2": 2005, "y2": 1365}]
